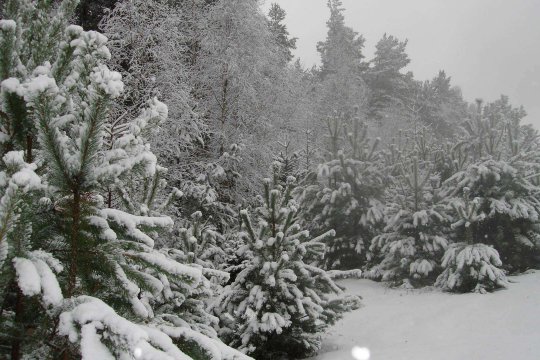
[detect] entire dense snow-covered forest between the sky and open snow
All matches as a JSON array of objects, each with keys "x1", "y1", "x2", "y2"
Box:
[{"x1": 0, "y1": 0, "x2": 540, "y2": 360}]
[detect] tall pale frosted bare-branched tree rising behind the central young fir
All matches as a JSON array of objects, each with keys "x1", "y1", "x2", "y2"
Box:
[{"x1": 193, "y1": 0, "x2": 297, "y2": 203}]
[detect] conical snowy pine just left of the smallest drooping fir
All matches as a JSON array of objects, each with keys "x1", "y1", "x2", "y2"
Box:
[{"x1": 367, "y1": 157, "x2": 448, "y2": 287}]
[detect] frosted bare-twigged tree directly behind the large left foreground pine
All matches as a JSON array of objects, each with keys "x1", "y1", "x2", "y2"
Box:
[{"x1": 100, "y1": 0, "x2": 206, "y2": 161}]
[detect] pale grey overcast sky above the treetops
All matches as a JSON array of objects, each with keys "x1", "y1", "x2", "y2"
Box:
[{"x1": 265, "y1": 0, "x2": 540, "y2": 129}]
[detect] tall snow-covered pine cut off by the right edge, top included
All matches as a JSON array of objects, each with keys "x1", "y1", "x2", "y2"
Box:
[{"x1": 444, "y1": 96, "x2": 540, "y2": 271}]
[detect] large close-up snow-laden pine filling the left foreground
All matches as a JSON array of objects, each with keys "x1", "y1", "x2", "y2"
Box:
[{"x1": 0, "y1": 0, "x2": 249, "y2": 359}]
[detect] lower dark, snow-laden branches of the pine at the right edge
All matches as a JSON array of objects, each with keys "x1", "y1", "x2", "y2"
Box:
[{"x1": 446, "y1": 157, "x2": 540, "y2": 271}]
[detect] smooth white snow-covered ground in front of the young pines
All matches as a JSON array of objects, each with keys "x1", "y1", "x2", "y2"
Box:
[{"x1": 312, "y1": 271, "x2": 540, "y2": 360}]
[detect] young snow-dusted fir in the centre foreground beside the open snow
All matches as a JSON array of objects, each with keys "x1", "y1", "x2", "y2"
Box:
[{"x1": 214, "y1": 173, "x2": 358, "y2": 359}]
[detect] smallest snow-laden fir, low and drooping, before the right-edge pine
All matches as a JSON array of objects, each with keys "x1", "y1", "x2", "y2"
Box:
[{"x1": 435, "y1": 188, "x2": 507, "y2": 293}]
